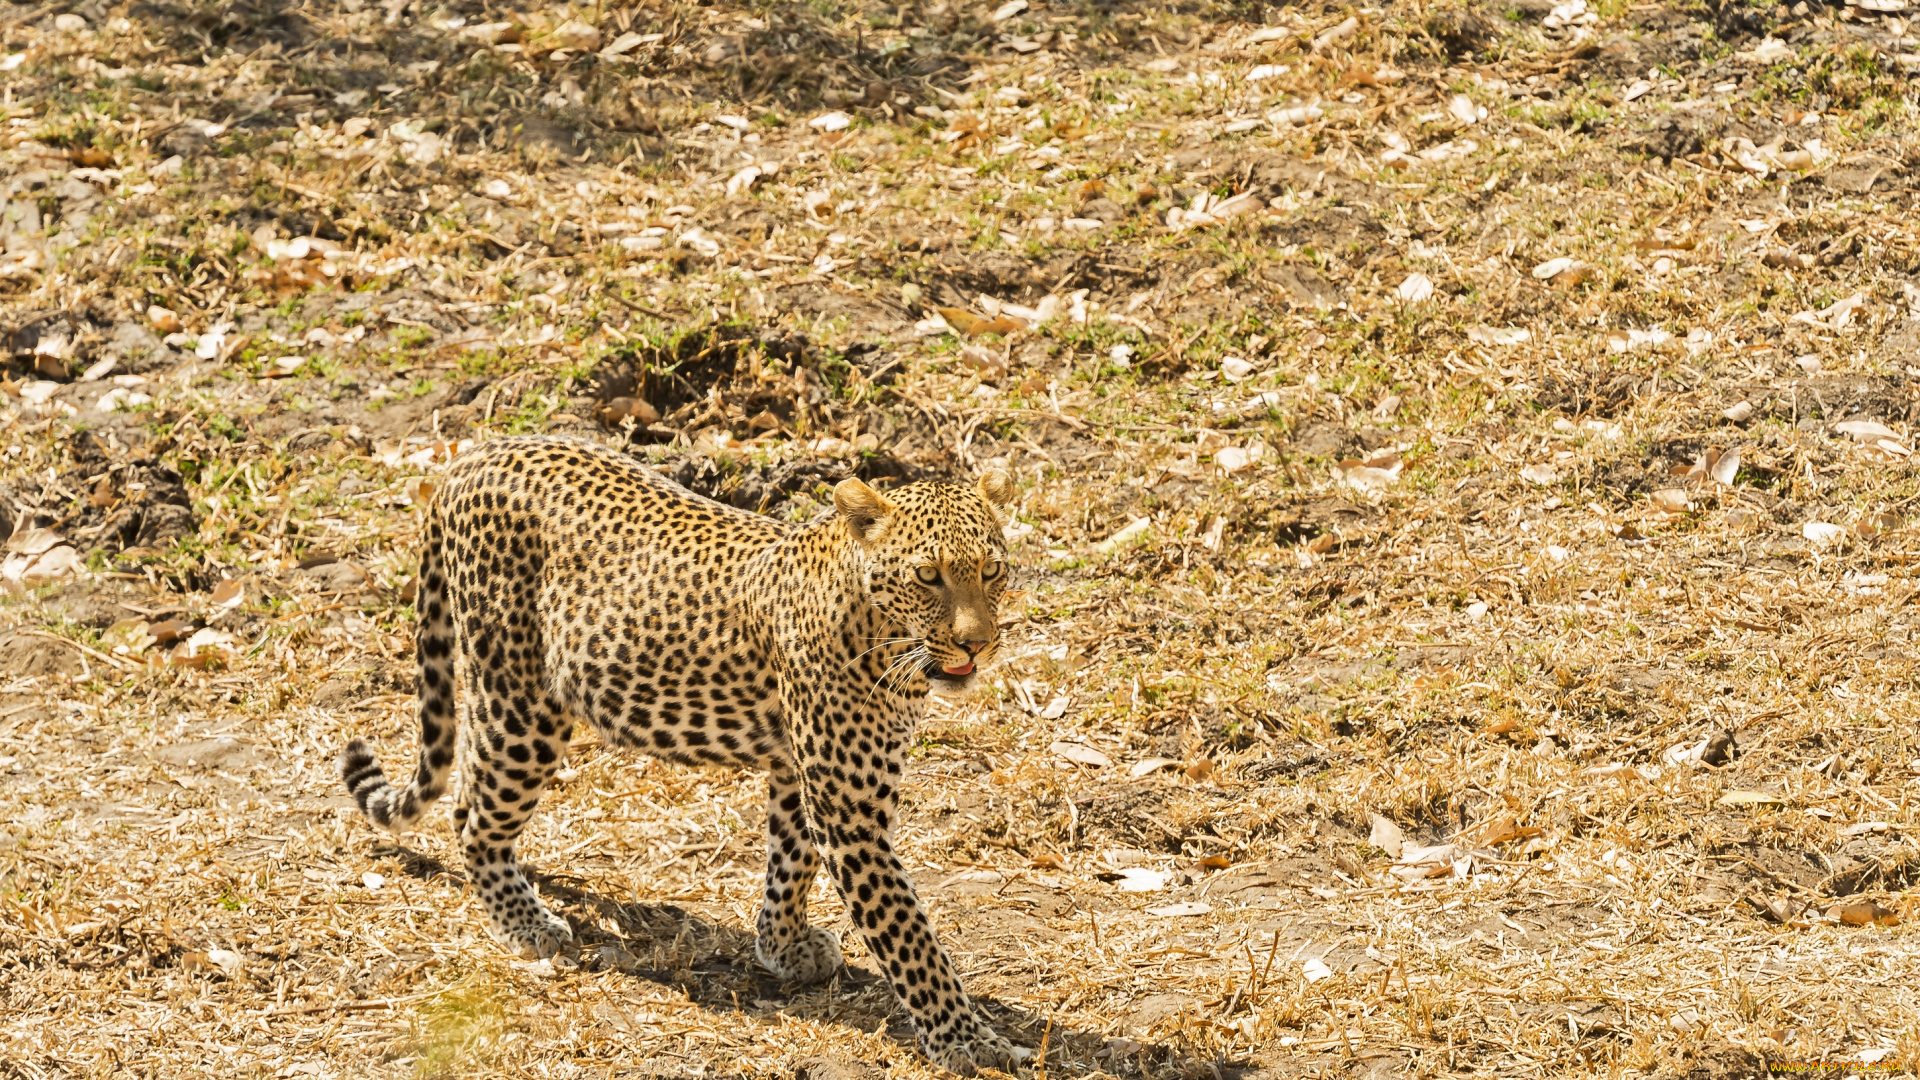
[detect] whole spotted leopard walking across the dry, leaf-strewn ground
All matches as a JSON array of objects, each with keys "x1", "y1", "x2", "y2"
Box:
[{"x1": 338, "y1": 436, "x2": 1031, "y2": 1074}]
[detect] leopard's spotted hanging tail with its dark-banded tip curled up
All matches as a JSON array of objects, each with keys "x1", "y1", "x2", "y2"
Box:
[{"x1": 340, "y1": 505, "x2": 455, "y2": 832}]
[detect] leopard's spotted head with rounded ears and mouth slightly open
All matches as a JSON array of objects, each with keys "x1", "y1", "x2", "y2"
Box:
[{"x1": 833, "y1": 469, "x2": 1014, "y2": 694}]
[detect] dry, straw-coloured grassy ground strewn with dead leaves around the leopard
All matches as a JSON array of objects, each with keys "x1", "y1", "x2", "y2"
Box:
[{"x1": 0, "y1": 0, "x2": 1920, "y2": 1080}]
